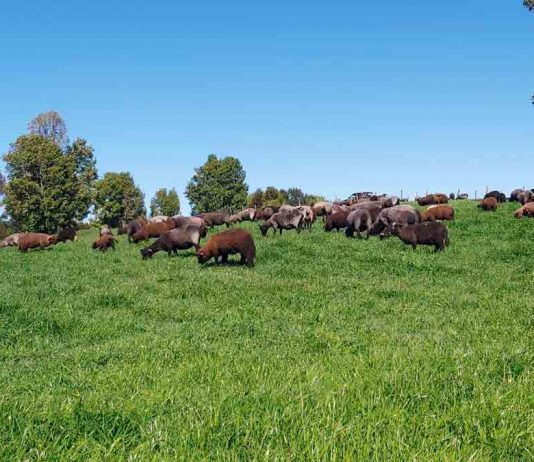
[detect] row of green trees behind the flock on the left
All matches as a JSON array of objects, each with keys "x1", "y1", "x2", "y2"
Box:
[{"x1": 0, "y1": 111, "x2": 321, "y2": 233}]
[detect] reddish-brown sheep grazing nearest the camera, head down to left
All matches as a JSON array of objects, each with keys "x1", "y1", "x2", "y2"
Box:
[{"x1": 197, "y1": 228, "x2": 256, "y2": 266}]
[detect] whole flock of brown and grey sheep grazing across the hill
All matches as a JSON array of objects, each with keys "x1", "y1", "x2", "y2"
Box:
[{"x1": 0, "y1": 189, "x2": 534, "y2": 266}]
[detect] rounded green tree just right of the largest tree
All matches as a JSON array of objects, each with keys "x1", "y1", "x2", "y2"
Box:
[{"x1": 95, "y1": 172, "x2": 146, "y2": 227}]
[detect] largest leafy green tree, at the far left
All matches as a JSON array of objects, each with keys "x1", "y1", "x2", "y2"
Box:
[{"x1": 4, "y1": 134, "x2": 94, "y2": 232}]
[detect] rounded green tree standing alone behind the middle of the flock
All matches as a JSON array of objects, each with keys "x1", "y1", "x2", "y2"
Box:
[{"x1": 185, "y1": 154, "x2": 248, "y2": 213}]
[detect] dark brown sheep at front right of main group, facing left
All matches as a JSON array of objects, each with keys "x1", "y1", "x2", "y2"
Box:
[{"x1": 389, "y1": 221, "x2": 449, "y2": 252}]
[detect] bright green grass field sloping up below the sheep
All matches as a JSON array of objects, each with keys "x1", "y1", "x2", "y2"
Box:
[{"x1": 0, "y1": 202, "x2": 534, "y2": 461}]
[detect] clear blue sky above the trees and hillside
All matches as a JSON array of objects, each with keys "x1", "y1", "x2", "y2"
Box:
[{"x1": 0, "y1": 0, "x2": 534, "y2": 213}]
